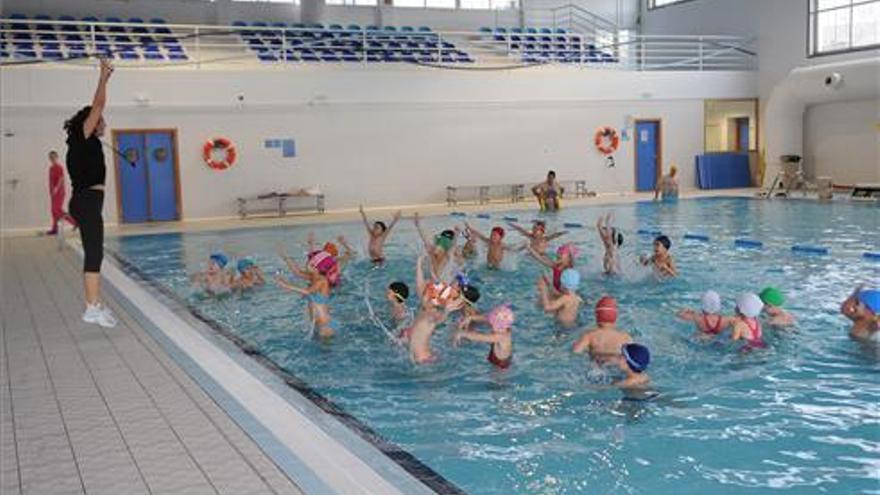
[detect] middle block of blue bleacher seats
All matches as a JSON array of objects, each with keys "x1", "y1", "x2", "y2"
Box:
[{"x1": 233, "y1": 21, "x2": 474, "y2": 64}]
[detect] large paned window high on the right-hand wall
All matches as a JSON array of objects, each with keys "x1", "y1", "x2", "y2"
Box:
[{"x1": 807, "y1": 0, "x2": 880, "y2": 55}]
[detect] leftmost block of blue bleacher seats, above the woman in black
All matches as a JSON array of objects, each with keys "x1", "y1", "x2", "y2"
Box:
[{"x1": 0, "y1": 14, "x2": 189, "y2": 62}]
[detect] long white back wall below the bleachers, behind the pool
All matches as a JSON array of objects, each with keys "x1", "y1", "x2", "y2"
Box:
[{"x1": 0, "y1": 66, "x2": 755, "y2": 232}]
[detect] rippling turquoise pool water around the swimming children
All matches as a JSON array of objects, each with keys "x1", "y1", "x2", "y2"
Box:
[{"x1": 108, "y1": 198, "x2": 880, "y2": 494}]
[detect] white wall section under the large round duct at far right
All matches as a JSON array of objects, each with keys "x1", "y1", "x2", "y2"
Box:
[{"x1": 804, "y1": 99, "x2": 880, "y2": 184}]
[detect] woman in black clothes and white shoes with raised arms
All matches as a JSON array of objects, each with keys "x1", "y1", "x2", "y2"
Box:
[{"x1": 64, "y1": 59, "x2": 116, "y2": 327}]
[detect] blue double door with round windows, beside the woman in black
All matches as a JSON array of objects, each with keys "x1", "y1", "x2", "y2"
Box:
[{"x1": 114, "y1": 130, "x2": 180, "y2": 223}]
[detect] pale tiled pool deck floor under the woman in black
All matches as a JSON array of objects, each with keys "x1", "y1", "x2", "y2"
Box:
[{"x1": 0, "y1": 238, "x2": 300, "y2": 495}]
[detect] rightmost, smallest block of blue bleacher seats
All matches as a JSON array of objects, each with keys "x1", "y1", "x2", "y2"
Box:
[{"x1": 480, "y1": 27, "x2": 618, "y2": 63}]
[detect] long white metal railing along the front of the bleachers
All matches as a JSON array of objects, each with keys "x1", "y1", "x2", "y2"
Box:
[{"x1": 0, "y1": 19, "x2": 756, "y2": 70}]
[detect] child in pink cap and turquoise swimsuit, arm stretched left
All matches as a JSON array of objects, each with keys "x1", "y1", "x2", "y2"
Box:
[{"x1": 275, "y1": 251, "x2": 336, "y2": 339}]
